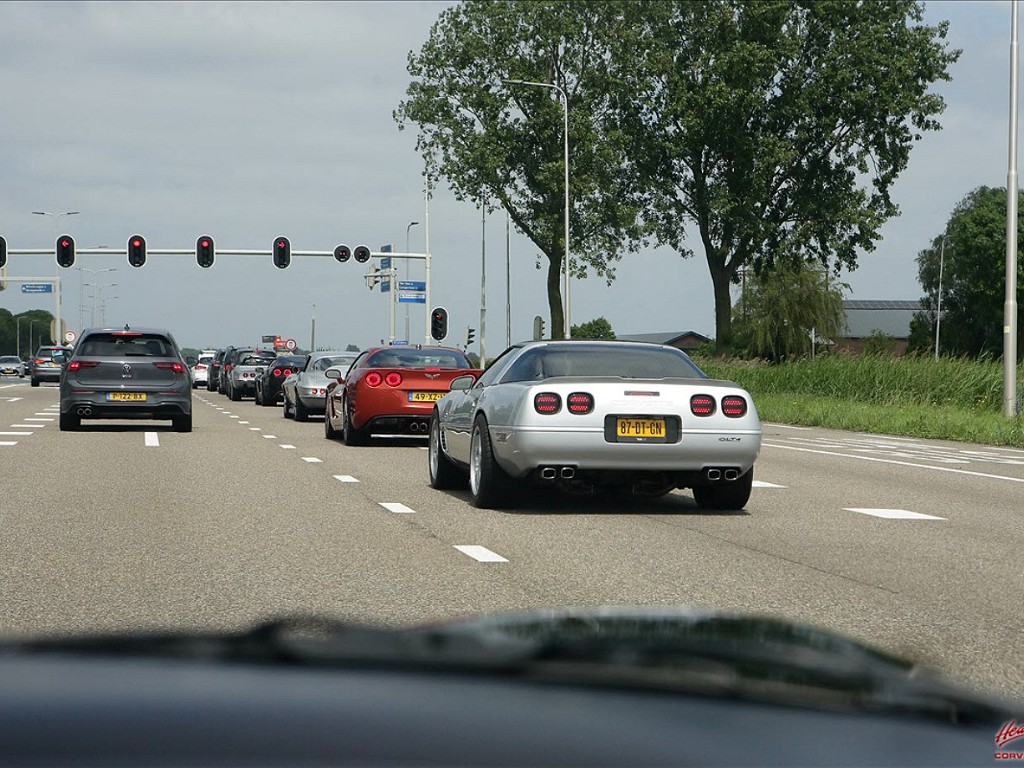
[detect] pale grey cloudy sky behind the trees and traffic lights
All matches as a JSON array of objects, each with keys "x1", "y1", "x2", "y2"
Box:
[{"x1": 0, "y1": 0, "x2": 1010, "y2": 355}]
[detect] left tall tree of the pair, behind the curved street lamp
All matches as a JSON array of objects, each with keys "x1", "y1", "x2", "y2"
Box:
[{"x1": 394, "y1": 0, "x2": 641, "y2": 338}]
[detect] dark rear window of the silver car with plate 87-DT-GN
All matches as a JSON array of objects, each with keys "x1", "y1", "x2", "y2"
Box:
[{"x1": 503, "y1": 344, "x2": 708, "y2": 381}]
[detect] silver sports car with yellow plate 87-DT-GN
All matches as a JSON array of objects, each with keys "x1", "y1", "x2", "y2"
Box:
[{"x1": 428, "y1": 341, "x2": 761, "y2": 509}]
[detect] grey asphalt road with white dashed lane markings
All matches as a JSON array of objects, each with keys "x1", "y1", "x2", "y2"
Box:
[{"x1": 0, "y1": 379, "x2": 1024, "y2": 696}]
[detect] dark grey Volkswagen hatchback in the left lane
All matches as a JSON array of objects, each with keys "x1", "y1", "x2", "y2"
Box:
[{"x1": 60, "y1": 326, "x2": 191, "y2": 432}]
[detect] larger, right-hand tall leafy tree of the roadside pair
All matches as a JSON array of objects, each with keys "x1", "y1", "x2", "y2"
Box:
[{"x1": 609, "y1": 0, "x2": 959, "y2": 349}]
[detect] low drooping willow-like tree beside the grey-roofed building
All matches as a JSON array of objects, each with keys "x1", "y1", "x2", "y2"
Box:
[{"x1": 733, "y1": 263, "x2": 846, "y2": 362}]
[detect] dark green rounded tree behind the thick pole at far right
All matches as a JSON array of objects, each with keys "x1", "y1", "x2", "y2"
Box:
[{"x1": 909, "y1": 186, "x2": 1024, "y2": 357}]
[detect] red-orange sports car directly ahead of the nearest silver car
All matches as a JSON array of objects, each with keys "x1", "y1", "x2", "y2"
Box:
[{"x1": 324, "y1": 346, "x2": 480, "y2": 445}]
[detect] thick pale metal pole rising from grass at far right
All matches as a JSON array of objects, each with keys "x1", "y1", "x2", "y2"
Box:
[{"x1": 1002, "y1": 0, "x2": 1018, "y2": 418}]
